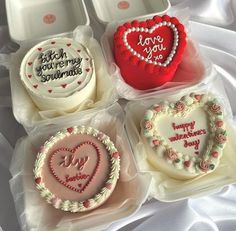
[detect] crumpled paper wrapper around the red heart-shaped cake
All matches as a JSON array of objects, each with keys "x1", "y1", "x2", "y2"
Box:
[{"x1": 101, "y1": 10, "x2": 211, "y2": 100}]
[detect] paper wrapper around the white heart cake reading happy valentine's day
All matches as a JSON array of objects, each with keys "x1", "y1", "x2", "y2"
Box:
[{"x1": 125, "y1": 76, "x2": 236, "y2": 202}]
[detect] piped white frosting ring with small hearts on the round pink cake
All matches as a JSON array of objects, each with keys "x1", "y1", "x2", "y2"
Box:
[{"x1": 33, "y1": 126, "x2": 120, "y2": 213}]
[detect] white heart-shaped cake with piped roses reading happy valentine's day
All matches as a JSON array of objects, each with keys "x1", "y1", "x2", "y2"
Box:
[{"x1": 142, "y1": 93, "x2": 227, "y2": 179}]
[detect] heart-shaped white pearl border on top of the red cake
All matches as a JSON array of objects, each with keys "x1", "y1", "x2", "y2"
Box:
[{"x1": 123, "y1": 21, "x2": 179, "y2": 67}]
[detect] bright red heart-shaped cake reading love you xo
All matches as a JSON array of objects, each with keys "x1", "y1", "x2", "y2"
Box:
[{"x1": 114, "y1": 15, "x2": 186, "y2": 90}]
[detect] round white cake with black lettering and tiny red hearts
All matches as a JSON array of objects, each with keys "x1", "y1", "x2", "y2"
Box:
[{"x1": 20, "y1": 38, "x2": 96, "y2": 111}]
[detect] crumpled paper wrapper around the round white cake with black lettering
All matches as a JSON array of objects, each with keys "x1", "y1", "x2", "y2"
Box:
[{"x1": 10, "y1": 26, "x2": 117, "y2": 131}]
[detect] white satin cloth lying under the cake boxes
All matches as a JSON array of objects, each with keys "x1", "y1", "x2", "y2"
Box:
[{"x1": 0, "y1": 0, "x2": 236, "y2": 231}]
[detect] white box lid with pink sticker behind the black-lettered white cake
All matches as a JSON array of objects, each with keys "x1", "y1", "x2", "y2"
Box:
[{"x1": 6, "y1": 0, "x2": 89, "y2": 43}]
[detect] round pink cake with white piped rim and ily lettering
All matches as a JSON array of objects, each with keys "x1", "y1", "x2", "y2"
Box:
[{"x1": 34, "y1": 126, "x2": 120, "y2": 212}]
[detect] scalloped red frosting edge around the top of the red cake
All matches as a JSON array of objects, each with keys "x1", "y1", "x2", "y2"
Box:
[{"x1": 114, "y1": 15, "x2": 187, "y2": 74}]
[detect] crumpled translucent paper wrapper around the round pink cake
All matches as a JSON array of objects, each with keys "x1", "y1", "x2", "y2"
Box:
[{"x1": 10, "y1": 104, "x2": 151, "y2": 231}]
